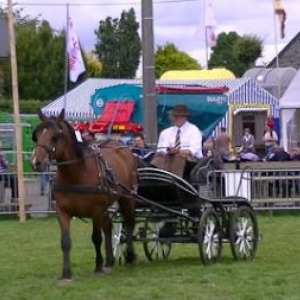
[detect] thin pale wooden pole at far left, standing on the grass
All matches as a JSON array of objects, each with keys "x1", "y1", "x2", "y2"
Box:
[{"x1": 7, "y1": 0, "x2": 26, "y2": 223}]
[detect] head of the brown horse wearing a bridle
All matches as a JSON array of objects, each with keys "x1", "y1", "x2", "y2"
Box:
[{"x1": 31, "y1": 109, "x2": 65, "y2": 172}]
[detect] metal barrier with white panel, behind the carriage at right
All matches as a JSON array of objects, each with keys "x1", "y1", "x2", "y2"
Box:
[{"x1": 209, "y1": 163, "x2": 300, "y2": 210}]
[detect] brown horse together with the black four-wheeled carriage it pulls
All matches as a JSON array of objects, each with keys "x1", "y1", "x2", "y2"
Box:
[{"x1": 32, "y1": 111, "x2": 258, "y2": 280}]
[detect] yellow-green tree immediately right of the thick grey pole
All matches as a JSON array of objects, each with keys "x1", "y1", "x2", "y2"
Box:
[{"x1": 154, "y1": 43, "x2": 201, "y2": 78}]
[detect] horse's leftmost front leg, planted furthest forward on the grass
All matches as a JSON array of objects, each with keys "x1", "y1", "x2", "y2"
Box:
[{"x1": 57, "y1": 210, "x2": 72, "y2": 281}]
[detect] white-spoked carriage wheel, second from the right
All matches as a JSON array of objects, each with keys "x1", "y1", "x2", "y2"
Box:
[{"x1": 198, "y1": 208, "x2": 222, "y2": 265}]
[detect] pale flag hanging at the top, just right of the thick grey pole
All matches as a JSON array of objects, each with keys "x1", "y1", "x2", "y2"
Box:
[{"x1": 204, "y1": 0, "x2": 217, "y2": 47}]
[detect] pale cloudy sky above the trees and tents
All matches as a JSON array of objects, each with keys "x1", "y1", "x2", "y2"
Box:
[{"x1": 0, "y1": 0, "x2": 300, "y2": 66}]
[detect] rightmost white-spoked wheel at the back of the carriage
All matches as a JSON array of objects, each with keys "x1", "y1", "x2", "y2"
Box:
[{"x1": 229, "y1": 206, "x2": 258, "y2": 260}]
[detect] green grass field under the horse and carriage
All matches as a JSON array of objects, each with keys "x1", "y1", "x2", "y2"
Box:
[{"x1": 0, "y1": 213, "x2": 300, "y2": 300}]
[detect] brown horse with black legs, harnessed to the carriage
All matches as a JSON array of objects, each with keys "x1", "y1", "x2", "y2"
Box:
[{"x1": 31, "y1": 110, "x2": 137, "y2": 280}]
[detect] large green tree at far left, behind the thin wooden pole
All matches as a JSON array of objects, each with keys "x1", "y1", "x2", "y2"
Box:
[{"x1": 0, "y1": 6, "x2": 65, "y2": 100}]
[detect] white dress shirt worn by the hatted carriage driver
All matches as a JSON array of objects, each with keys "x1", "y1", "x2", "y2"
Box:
[{"x1": 157, "y1": 121, "x2": 203, "y2": 158}]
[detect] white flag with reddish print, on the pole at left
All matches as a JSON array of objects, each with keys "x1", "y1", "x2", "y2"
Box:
[{"x1": 67, "y1": 18, "x2": 85, "y2": 82}]
